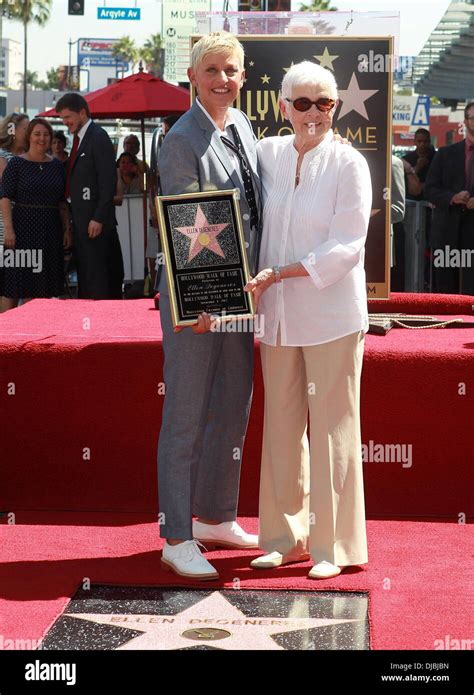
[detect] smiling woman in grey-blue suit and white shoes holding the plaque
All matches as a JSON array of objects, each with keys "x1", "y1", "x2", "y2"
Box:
[{"x1": 158, "y1": 32, "x2": 260, "y2": 580}]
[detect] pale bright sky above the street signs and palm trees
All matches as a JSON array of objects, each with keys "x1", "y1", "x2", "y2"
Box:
[{"x1": 3, "y1": 0, "x2": 449, "y2": 78}]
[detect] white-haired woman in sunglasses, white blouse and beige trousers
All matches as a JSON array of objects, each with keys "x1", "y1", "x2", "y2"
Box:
[{"x1": 246, "y1": 62, "x2": 372, "y2": 579}]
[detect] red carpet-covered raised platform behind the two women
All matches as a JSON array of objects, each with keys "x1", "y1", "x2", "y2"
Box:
[{"x1": 0, "y1": 294, "x2": 474, "y2": 520}]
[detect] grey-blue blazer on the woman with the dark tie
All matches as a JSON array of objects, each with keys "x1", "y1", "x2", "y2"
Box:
[{"x1": 158, "y1": 102, "x2": 262, "y2": 290}]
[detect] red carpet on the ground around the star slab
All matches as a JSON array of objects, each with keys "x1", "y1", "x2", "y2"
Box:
[{"x1": 0, "y1": 512, "x2": 473, "y2": 650}]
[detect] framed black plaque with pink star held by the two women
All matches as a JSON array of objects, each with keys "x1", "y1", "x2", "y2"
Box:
[{"x1": 156, "y1": 188, "x2": 255, "y2": 326}]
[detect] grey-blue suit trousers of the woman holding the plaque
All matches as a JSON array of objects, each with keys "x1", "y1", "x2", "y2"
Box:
[{"x1": 158, "y1": 292, "x2": 253, "y2": 540}]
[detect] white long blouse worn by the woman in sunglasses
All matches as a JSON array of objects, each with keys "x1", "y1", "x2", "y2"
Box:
[{"x1": 257, "y1": 130, "x2": 372, "y2": 346}]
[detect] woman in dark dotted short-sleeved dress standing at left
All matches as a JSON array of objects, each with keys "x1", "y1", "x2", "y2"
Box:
[{"x1": 1, "y1": 118, "x2": 72, "y2": 309}]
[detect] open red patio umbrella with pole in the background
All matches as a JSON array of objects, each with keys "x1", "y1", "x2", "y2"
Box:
[{"x1": 38, "y1": 70, "x2": 190, "y2": 264}]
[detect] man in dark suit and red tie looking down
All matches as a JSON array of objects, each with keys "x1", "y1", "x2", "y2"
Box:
[{"x1": 56, "y1": 92, "x2": 123, "y2": 299}]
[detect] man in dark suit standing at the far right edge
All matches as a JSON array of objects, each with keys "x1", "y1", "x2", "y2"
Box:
[{"x1": 424, "y1": 102, "x2": 474, "y2": 295}]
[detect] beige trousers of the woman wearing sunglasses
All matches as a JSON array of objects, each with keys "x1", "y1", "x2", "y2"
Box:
[{"x1": 259, "y1": 331, "x2": 368, "y2": 566}]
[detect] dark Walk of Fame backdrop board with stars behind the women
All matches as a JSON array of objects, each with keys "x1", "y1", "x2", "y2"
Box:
[{"x1": 191, "y1": 35, "x2": 393, "y2": 299}]
